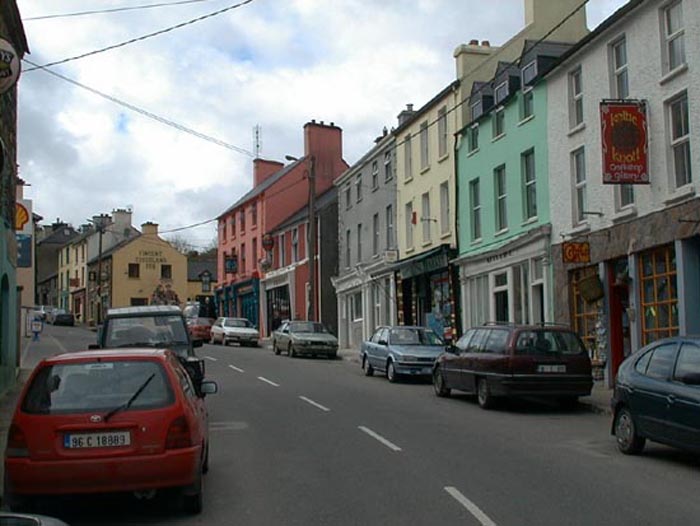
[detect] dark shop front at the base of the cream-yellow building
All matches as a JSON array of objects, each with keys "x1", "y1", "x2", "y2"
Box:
[{"x1": 394, "y1": 245, "x2": 459, "y2": 341}]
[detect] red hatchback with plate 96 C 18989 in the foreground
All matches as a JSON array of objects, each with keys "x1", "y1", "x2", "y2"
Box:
[{"x1": 5, "y1": 349, "x2": 217, "y2": 513}]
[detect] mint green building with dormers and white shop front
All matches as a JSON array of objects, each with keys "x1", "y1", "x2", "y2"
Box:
[{"x1": 455, "y1": 41, "x2": 570, "y2": 329}]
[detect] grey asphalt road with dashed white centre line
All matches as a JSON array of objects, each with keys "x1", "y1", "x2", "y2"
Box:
[{"x1": 16, "y1": 327, "x2": 700, "y2": 526}]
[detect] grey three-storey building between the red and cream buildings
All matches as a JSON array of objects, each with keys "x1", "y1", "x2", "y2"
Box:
[{"x1": 333, "y1": 129, "x2": 398, "y2": 348}]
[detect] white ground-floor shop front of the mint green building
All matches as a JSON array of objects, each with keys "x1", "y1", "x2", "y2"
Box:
[{"x1": 456, "y1": 225, "x2": 553, "y2": 329}]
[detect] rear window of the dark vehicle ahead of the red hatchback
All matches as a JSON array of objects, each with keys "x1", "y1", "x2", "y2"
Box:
[{"x1": 105, "y1": 316, "x2": 188, "y2": 348}]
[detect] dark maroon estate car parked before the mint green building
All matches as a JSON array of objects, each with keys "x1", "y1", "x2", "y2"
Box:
[{"x1": 433, "y1": 323, "x2": 593, "y2": 409}]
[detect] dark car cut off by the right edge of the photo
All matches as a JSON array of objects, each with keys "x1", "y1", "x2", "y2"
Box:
[{"x1": 611, "y1": 336, "x2": 700, "y2": 454}]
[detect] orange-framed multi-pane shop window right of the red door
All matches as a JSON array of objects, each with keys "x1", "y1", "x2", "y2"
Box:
[{"x1": 639, "y1": 245, "x2": 679, "y2": 345}]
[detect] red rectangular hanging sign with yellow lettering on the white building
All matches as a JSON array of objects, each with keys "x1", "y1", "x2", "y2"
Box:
[{"x1": 600, "y1": 100, "x2": 649, "y2": 184}]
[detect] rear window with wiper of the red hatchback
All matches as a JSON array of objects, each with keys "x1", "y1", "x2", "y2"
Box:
[{"x1": 22, "y1": 360, "x2": 175, "y2": 414}]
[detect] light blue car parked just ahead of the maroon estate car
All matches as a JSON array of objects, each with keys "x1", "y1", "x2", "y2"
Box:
[{"x1": 360, "y1": 326, "x2": 445, "y2": 382}]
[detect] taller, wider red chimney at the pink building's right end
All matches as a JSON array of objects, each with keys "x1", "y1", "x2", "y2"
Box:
[{"x1": 304, "y1": 120, "x2": 348, "y2": 194}]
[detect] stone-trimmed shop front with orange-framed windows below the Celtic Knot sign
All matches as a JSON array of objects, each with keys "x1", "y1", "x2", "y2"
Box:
[{"x1": 552, "y1": 199, "x2": 700, "y2": 386}]
